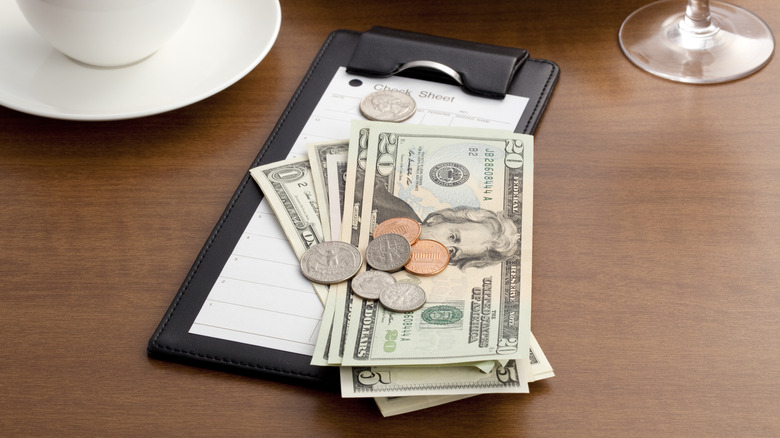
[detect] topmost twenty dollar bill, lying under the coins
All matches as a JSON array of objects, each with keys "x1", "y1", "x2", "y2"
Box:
[{"x1": 334, "y1": 122, "x2": 533, "y2": 366}]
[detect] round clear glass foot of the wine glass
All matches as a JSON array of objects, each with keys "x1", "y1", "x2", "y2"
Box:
[{"x1": 618, "y1": 0, "x2": 775, "y2": 84}]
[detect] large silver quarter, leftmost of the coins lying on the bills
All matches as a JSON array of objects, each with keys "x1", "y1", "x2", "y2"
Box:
[{"x1": 301, "y1": 240, "x2": 363, "y2": 284}]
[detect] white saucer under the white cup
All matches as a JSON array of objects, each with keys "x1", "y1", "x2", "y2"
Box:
[{"x1": 0, "y1": 0, "x2": 282, "y2": 120}]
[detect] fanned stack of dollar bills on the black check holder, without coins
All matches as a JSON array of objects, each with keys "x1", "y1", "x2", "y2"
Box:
[{"x1": 251, "y1": 121, "x2": 553, "y2": 416}]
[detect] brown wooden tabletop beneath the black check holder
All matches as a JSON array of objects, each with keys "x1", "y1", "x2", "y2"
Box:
[{"x1": 0, "y1": 0, "x2": 780, "y2": 437}]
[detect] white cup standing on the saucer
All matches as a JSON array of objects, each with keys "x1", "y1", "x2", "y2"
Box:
[{"x1": 17, "y1": 0, "x2": 195, "y2": 67}]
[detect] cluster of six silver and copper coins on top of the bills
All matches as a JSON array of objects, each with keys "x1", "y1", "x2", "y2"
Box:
[{"x1": 301, "y1": 217, "x2": 449, "y2": 312}]
